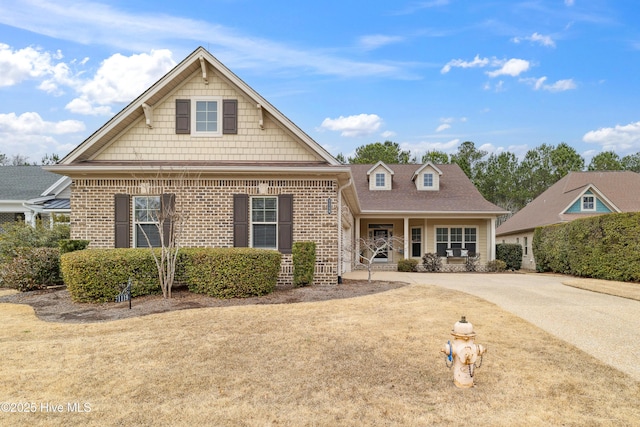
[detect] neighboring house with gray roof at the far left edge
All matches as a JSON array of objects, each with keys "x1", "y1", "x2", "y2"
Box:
[{"x1": 0, "y1": 166, "x2": 71, "y2": 231}]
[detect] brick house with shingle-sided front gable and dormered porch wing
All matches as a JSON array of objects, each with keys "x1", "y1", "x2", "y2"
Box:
[{"x1": 47, "y1": 48, "x2": 505, "y2": 284}]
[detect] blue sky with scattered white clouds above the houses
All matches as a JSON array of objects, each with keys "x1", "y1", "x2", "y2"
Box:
[{"x1": 0, "y1": 0, "x2": 640, "y2": 163}]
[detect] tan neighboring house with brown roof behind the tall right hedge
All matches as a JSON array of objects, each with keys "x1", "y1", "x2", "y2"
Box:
[{"x1": 496, "y1": 171, "x2": 640, "y2": 270}]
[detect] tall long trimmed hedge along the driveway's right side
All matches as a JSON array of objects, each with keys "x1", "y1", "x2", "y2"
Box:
[{"x1": 533, "y1": 213, "x2": 640, "y2": 282}]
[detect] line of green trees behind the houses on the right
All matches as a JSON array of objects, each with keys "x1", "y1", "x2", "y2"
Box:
[{"x1": 336, "y1": 141, "x2": 640, "y2": 214}]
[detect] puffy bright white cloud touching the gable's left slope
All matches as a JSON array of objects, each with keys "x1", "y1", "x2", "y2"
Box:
[{"x1": 65, "y1": 49, "x2": 175, "y2": 115}]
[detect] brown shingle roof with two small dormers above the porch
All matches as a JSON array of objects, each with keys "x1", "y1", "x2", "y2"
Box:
[{"x1": 348, "y1": 164, "x2": 507, "y2": 216}]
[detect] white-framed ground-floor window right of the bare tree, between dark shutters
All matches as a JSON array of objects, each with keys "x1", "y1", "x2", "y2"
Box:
[{"x1": 251, "y1": 197, "x2": 278, "y2": 249}]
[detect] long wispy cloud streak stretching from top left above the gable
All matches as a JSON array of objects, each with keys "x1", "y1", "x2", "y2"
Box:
[{"x1": 0, "y1": 0, "x2": 420, "y2": 79}]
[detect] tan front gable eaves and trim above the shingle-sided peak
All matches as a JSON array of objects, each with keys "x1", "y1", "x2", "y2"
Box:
[{"x1": 54, "y1": 47, "x2": 339, "y2": 167}]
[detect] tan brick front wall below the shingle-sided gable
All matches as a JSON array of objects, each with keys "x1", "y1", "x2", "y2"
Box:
[{"x1": 71, "y1": 178, "x2": 338, "y2": 285}]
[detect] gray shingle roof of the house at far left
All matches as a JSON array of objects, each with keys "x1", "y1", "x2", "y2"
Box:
[{"x1": 0, "y1": 166, "x2": 62, "y2": 200}]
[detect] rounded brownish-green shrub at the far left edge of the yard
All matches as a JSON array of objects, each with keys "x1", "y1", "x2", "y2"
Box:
[{"x1": 0, "y1": 248, "x2": 62, "y2": 292}]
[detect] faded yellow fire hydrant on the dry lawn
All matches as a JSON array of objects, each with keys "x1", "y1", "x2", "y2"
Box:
[{"x1": 441, "y1": 316, "x2": 487, "y2": 388}]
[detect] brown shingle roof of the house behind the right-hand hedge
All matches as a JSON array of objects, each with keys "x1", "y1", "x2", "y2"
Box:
[{"x1": 496, "y1": 171, "x2": 640, "y2": 236}]
